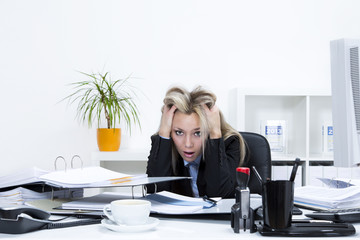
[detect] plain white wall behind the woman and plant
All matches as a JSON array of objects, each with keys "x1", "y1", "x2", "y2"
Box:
[{"x1": 0, "y1": 0, "x2": 360, "y2": 175}]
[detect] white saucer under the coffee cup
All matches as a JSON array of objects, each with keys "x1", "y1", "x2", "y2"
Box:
[{"x1": 101, "y1": 217, "x2": 160, "y2": 232}]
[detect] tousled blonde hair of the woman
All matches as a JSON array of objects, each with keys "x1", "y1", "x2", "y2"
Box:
[{"x1": 161, "y1": 86, "x2": 246, "y2": 172}]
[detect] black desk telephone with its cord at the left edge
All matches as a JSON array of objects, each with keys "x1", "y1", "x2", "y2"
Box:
[{"x1": 0, "y1": 205, "x2": 102, "y2": 234}]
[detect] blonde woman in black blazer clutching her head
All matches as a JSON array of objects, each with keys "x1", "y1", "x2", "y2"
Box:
[{"x1": 147, "y1": 87, "x2": 245, "y2": 198}]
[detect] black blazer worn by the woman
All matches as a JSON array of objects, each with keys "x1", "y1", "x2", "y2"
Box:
[{"x1": 146, "y1": 135, "x2": 240, "y2": 198}]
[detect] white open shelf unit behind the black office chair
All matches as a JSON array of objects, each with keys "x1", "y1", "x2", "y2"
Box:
[{"x1": 229, "y1": 89, "x2": 333, "y2": 185}]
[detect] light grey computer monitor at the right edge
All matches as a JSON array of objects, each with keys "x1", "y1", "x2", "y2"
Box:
[{"x1": 330, "y1": 39, "x2": 360, "y2": 167}]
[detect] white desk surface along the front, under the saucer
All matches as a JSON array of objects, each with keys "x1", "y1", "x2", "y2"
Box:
[{"x1": 0, "y1": 209, "x2": 360, "y2": 240}]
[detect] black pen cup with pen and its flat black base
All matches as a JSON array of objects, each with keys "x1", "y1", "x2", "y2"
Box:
[{"x1": 257, "y1": 158, "x2": 356, "y2": 237}]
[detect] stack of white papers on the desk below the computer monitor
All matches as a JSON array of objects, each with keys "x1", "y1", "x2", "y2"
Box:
[{"x1": 294, "y1": 186, "x2": 360, "y2": 209}]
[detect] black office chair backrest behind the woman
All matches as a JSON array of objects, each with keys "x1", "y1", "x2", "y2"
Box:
[{"x1": 240, "y1": 132, "x2": 271, "y2": 194}]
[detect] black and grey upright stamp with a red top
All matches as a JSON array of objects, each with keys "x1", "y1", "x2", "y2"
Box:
[{"x1": 231, "y1": 167, "x2": 256, "y2": 233}]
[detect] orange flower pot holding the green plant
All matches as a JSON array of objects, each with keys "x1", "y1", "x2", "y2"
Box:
[{"x1": 97, "y1": 128, "x2": 121, "y2": 152}]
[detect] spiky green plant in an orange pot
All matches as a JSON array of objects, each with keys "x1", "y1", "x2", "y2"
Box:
[{"x1": 65, "y1": 72, "x2": 141, "y2": 151}]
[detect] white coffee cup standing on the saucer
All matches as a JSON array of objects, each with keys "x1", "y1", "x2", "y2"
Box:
[{"x1": 103, "y1": 199, "x2": 151, "y2": 225}]
